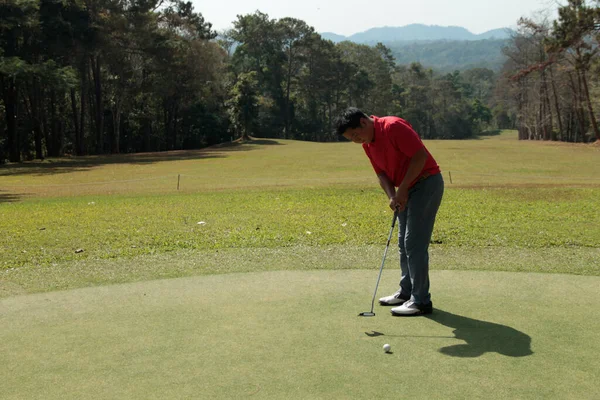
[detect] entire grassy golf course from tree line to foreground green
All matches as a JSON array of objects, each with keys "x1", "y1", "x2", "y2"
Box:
[{"x1": 0, "y1": 131, "x2": 600, "y2": 400}]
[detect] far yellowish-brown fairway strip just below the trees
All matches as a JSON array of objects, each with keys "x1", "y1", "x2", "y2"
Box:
[{"x1": 0, "y1": 131, "x2": 600, "y2": 201}]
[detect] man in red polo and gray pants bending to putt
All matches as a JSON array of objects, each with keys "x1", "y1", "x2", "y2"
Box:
[{"x1": 336, "y1": 108, "x2": 444, "y2": 316}]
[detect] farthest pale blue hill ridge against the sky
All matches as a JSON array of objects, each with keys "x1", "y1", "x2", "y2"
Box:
[{"x1": 321, "y1": 24, "x2": 511, "y2": 44}]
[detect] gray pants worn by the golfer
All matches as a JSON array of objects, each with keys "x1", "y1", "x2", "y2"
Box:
[{"x1": 398, "y1": 174, "x2": 444, "y2": 304}]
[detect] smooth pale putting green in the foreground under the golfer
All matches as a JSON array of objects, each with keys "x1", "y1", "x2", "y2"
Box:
[{"x1": 0, "y1": 270, "x2": 600, "y2": 399}]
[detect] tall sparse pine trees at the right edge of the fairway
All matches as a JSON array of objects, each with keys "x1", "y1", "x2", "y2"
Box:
[{"x1": 497, "y1": 0, "x2": 600, "y2": 142}]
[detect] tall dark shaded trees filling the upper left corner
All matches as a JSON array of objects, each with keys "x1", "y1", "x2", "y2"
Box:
[{"x1": 0, "y1": 0, "x2": 229, "y2": 161}]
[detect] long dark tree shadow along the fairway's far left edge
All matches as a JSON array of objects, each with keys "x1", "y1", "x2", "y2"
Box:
[{"x1": 0, "y1": 139, "x2": 282, "y2": 176}]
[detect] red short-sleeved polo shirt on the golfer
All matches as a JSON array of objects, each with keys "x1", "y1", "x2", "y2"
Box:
[{"x1": 363, "y1": 116, "x2": 440, "y2": 187}]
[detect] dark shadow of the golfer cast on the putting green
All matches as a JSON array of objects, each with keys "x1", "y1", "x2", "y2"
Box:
[{"x1": 426, "y1": 308, "x2": 533, "y2": 358}]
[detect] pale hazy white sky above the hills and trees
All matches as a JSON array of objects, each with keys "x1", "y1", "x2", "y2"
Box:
[{"x1": 191, "y1": 0, "x2": 564, "y2": 36}]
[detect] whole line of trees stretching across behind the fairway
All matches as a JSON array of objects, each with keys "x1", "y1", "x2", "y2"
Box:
[{"x1": 0, "y1": 0, "x2": 598, "y2": 162}]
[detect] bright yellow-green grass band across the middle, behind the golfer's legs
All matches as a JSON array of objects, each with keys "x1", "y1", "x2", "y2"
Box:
[{"x1": 0, "y1": 188, "x2": 600, "y2": 274}]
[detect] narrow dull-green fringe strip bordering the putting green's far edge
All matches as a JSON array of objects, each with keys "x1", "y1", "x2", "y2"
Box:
[{"x1": 0, "y1": 245, "x2": 600, "y2": 298}]
